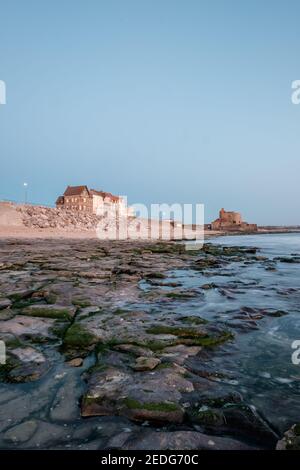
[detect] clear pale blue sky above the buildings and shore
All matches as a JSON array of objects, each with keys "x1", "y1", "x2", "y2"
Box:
[{"x1": 0, "y1": 0, "x2": 300, "y2": 224}]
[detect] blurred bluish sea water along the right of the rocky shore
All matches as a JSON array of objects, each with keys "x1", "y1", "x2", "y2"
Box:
[{"x1": 185, "y1": 234, "x2": 300, "y2": 432}]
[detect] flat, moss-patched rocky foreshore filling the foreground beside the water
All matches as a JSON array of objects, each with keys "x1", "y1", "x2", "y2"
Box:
[{"x1": 0, "y1": 240, "x2": 298, "y2": 449}]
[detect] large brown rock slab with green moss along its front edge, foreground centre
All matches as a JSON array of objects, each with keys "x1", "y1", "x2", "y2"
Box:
[{"x1": 81, "y1": 362, "x2": 194, "y2": 423}]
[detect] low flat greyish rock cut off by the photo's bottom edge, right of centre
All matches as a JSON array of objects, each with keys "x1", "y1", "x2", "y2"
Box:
[{"x1": 107, "y1": 430, "x2": 254, "y2": 450}]
